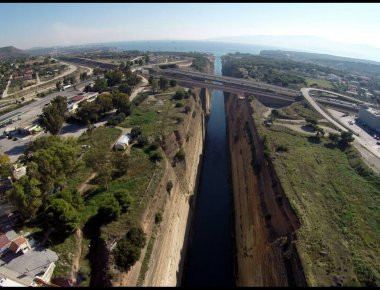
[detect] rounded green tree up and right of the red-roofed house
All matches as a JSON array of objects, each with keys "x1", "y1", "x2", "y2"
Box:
[{"x1": 46, "y1": 198, "x2": 80, "y2": 234}]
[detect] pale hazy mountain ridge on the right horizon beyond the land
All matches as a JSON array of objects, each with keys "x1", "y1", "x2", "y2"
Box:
[{"x1": 209, "y1": 35, "x2": 380, "y2": 61}]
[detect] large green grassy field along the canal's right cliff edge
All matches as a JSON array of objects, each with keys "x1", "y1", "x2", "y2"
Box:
[{"x1": 260, "y1": 125, "x2": 380, "y2": 286}]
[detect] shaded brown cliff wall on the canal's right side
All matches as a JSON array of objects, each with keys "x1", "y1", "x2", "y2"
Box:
[{"x1": 225, "y1": 94, "x2": 306, "y2": 286}]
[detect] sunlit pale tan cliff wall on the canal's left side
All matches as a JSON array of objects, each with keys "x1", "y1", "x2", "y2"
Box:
[{"x1": 143, "y1": 89, "x2": 205, "y2": 286}]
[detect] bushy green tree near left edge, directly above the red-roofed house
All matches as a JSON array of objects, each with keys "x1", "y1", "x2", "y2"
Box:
[{"x1": 7, "y1": 175, "x2": 43, "y2": 219}]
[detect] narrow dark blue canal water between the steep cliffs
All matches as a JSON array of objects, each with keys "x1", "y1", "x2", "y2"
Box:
[{"x1": 182, "y1": 56, "x2": 235, "y2": 287}]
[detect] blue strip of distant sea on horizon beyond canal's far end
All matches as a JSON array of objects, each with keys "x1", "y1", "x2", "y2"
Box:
[{"x1": 95, "y1": 40, "x2": 278, "y2": 56}]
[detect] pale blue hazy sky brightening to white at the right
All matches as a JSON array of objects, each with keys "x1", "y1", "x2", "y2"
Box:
[{"x1": 0, "y1": 3, "x2": 380, "y2": 49}]
